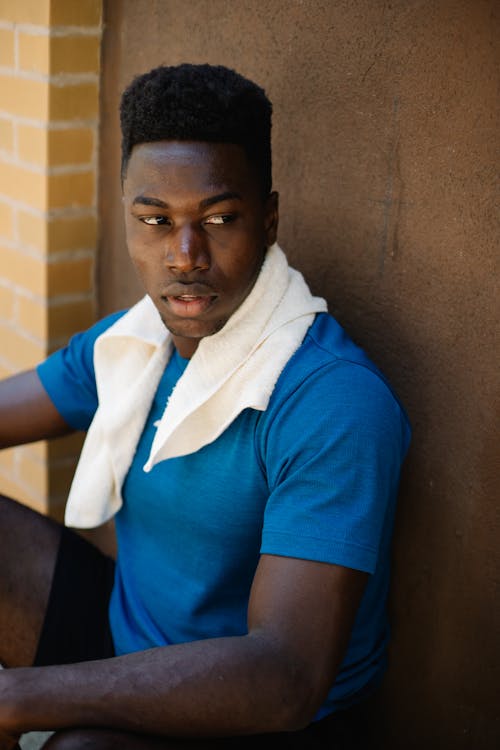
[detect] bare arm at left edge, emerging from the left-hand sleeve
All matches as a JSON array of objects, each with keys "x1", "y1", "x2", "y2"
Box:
[{"x1": 0, "y1": 370, "x2": 72, "y2": 448}]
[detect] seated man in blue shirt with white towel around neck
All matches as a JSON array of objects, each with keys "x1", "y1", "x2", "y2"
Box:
[{"x1": 0, "y1": 65, "x2": 409, "y2": 749}]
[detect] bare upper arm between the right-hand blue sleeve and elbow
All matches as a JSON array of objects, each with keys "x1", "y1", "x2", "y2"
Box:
[{"x1": 248, "y1": 554, "x2": 368, "y2": 707}]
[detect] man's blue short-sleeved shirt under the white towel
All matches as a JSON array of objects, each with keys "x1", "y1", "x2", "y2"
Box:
[{"x1": 38, "y1": 313, "x2": 410, "y2": 718}]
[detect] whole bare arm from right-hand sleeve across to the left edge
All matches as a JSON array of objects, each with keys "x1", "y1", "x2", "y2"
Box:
[{"x1": 0, "y1": 555, "x2": 367, "y2": 737}]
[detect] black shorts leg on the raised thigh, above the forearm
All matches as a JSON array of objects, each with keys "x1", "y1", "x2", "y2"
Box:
[{"x1": 34, "y1": 527, "x2": 115, "y2": 667}]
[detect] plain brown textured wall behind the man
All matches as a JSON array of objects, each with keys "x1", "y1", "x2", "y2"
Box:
[{"x1": 99, "y1": 0, "x2": 500, "y2": 750}]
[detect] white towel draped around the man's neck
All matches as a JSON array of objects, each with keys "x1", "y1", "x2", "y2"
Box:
[{"x1": 65, "y1": 244, "x2": 327, "y2": 528}]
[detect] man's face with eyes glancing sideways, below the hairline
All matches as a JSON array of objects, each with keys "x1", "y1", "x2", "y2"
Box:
[{"x1": 123, "y1": 141, "x2": 278, "y2": 357}]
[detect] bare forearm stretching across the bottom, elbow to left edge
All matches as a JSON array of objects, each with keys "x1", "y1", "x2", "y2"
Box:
[{"x1": 0, "y1": 636, "x2": 311, "y2": 736}]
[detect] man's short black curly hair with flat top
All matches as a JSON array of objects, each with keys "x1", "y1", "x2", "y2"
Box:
[{"x1": 120, "y1": 63, "x2": 272, "y2": 197}]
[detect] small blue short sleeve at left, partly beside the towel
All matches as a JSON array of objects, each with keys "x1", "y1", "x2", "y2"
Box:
[{"x1": 37, "y1": 311, "x2": 124, "y2": 430}]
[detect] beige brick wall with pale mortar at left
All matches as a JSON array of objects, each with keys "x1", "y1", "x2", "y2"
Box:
[{"x1": 0, "y1": 0, "x2": 102, "y2": 517}]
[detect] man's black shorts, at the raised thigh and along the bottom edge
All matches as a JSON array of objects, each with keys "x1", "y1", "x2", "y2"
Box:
[{"x1": 34, "y1": 528, "x2": 371, "y2": 750}]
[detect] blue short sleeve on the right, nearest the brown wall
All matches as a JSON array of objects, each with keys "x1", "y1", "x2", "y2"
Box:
[{"x1": 261, "y1": 361, "x2": 409, "y2": 573}]
